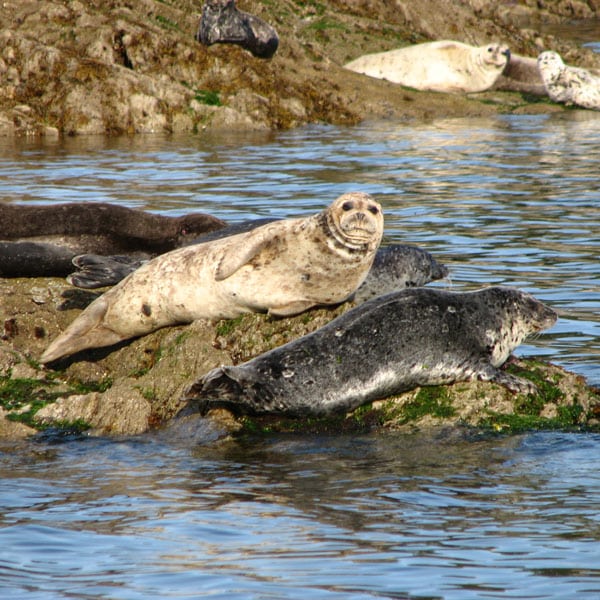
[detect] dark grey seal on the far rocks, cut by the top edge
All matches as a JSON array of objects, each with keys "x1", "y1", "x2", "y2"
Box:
[{"x1": 196, "y1": 0, "x2": 279, "y2": 58}]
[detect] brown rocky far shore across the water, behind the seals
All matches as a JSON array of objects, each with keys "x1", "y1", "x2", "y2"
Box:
[{"x1": 0, "y1": 0, "x2": 600, "y2": 136}]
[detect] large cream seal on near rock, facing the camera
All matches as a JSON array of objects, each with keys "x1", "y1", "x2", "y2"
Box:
[{"x1": 41, "y1": 192, "x2": 383, "y2": 363}]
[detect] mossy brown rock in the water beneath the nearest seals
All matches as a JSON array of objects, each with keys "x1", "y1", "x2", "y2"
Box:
[{"x1": 0, "y1": 278, "x2": 600, "y2": 438}]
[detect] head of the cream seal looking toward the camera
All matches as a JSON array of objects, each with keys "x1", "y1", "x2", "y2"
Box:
[{"x1": 323, "y1": 192, "x2": 383, "y2": 251}]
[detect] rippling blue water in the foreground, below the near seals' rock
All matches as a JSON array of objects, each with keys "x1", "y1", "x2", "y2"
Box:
[{"x1": 0, "y1": 432, "x2": 600, "y2": 599}]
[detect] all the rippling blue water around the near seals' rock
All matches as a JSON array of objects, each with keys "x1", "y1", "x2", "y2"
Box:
[{"x1": 0, "y1": 111, "x2": 600, "y2": 600}]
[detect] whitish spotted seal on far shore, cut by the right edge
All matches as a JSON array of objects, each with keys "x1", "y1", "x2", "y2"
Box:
[{"x1": 537, "y1": 51, "x2": 600, "y2": 110}]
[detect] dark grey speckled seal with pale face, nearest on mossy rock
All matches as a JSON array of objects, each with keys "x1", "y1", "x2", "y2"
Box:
[{"x1": 184, "y1": 287, "x2": 556, "y2": 416}]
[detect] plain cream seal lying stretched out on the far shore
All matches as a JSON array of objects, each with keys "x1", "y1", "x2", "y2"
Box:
[{"x1": 344, "y1": 40, "x2": 510, "y2": 93}]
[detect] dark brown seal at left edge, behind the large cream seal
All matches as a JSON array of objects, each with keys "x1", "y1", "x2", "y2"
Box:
[{"x1": 0, "y1": 202, "x2": 225, "y2": 277}]
